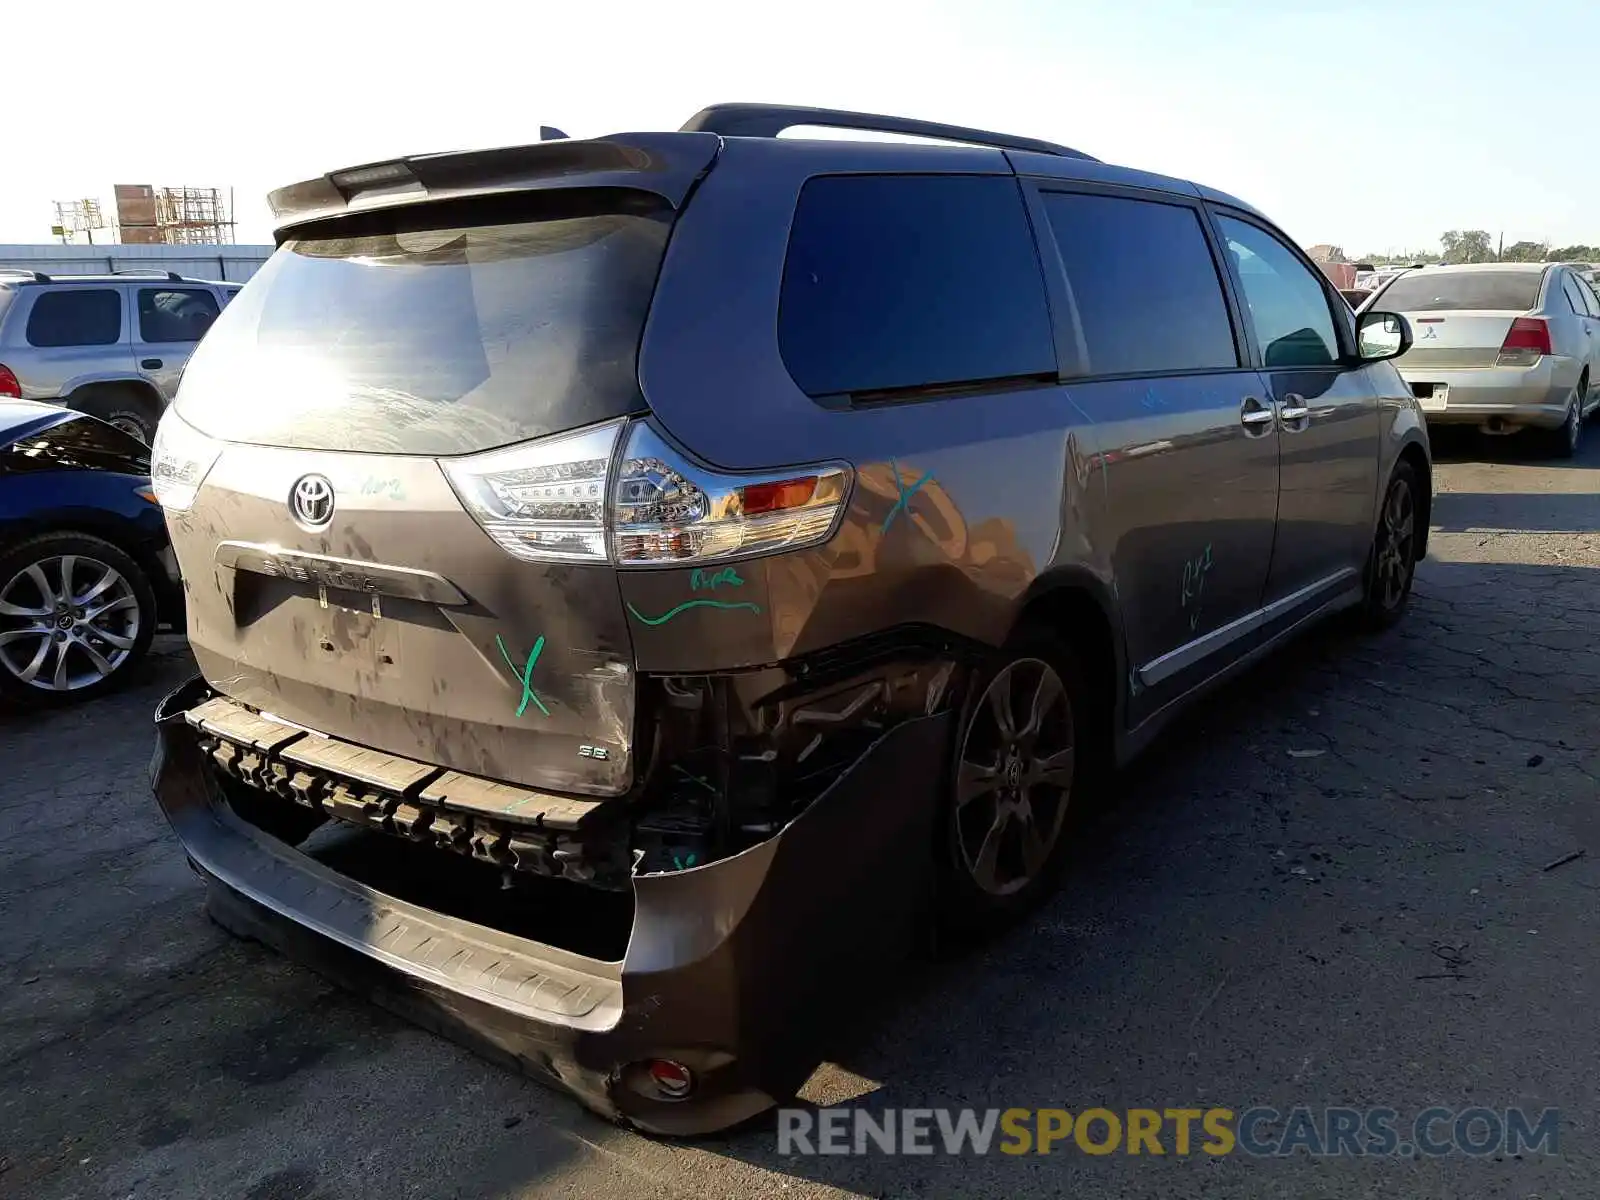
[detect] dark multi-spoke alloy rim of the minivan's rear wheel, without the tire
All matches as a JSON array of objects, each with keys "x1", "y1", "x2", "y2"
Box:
[{"x1": 954, "y1": 658, "x2": 1075, "y2": 896}]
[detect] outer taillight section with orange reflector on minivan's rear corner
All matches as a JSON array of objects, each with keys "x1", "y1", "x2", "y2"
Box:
[{"x1": 611, "y1": 421, "x2": 851, "y2": 566}]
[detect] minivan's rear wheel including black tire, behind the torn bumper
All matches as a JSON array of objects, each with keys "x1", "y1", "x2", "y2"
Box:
[{"x1": 936, "y1": 629, "x2": 1091, "y2": 936}]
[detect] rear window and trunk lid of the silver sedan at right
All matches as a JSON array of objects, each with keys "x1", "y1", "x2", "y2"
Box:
[{"x1": 1366, "y1": 270, "x2": 1542, "y2": 371}]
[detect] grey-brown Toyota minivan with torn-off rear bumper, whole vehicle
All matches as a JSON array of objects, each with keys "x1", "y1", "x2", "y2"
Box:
[{"x1": 152, "y1": 106, "x2": 1430, "y2": 1134}]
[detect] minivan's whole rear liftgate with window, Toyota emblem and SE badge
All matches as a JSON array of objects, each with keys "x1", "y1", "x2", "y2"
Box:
[{"x1": 157, "y1": 187, "x2": 694, "y2": 795}]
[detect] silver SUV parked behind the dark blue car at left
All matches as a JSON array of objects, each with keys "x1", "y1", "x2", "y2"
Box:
[{"x1": 0, "y1": 269, "x2": 242, "y2": 445}]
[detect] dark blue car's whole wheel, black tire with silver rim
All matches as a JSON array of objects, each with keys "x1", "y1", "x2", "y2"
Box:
[{"x1": 0, "y1": 533, "x2": 155, "y2": 706}]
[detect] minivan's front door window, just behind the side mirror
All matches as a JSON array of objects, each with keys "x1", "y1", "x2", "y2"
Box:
[{"x1": 1219, "y1": 216, "x2": 1339, "y2": 368}]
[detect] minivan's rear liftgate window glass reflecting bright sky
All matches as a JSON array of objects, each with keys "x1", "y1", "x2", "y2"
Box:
[{"x1": 178, "y1": 189, "x2": 672, "y2": 454}]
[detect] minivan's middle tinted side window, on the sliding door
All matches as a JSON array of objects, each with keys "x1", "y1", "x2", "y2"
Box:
[{"x1": 1045, "y1": 192, "x2": 1238, "y2": 374}]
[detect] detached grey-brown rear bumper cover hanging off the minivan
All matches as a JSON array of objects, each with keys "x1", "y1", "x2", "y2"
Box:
[{"x1": 150, "y1": 677, "x2": 950, "y2": 1134}]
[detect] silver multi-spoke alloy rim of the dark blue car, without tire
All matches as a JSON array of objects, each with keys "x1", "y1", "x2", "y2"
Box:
[{"x1": 0, "y1": 554, "x2": 142, "y2": 693}]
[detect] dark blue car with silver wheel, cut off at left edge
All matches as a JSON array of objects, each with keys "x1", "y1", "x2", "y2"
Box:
[{"x1": 0, "y1": 400, "x2": 182, "y2": 707}]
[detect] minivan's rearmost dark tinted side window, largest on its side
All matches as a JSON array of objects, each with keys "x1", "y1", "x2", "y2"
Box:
[{"x1": 778, "y1": 176, "x2": 1056, "y2": 395}]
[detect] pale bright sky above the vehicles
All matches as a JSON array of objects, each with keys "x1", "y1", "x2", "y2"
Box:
[{"x1": 0, "y1": 0, "x2": 1600, "y2": 254}]
